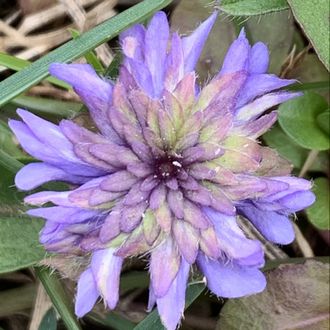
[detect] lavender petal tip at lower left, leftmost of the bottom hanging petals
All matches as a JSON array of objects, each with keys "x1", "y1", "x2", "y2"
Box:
[{"x1": 75, "y1": 268, "x2": 99, "y2": 317}]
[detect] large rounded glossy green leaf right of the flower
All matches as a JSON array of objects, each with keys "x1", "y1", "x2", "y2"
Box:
[{"x1": 279, "y1": 92, "x2": 329, "y2": 150}]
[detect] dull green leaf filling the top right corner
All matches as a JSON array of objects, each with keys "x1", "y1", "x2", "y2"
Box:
[{"x1": 287, "y1": 0, "x2": 330, "y2": 70}]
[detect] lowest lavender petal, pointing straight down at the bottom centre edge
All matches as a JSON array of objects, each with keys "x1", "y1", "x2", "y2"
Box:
[{"x1": 157, "y1": 259, "x2": 190, "y2": 330}]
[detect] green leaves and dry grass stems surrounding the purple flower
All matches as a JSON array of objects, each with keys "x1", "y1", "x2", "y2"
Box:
[{"x1": 0, "y1": 0, "x2": 330, "y2": 330}]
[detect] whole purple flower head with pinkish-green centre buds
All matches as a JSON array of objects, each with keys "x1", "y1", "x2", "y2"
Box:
[{"x1": 10, "y1": 12, "x2": 314, "y2": 329}]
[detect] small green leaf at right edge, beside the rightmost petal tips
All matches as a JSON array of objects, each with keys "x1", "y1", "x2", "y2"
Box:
[{"x1": 306, "y1": 178, "x2": 330, "y2": 230}]
